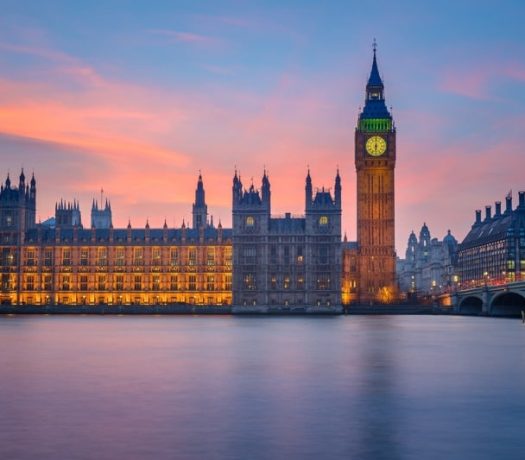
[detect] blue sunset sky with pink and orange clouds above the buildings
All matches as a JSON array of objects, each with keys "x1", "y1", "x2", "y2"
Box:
[{"x1": 0, "y1": 0, "x2": 525, "y2": 255}]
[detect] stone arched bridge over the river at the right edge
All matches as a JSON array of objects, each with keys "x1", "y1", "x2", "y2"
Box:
[{"x1": 450, "y1": 280, "x2": 525, "y2": 316}]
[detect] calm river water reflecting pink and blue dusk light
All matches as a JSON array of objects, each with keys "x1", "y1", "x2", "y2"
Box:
[{"x1": 0, "y1": 316, "x2": 525, "y2": 460}]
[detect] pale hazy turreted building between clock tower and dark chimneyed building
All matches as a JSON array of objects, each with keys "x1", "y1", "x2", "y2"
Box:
[{"x1": 397, "y1": 224, "x2": 458, "y2": 296}]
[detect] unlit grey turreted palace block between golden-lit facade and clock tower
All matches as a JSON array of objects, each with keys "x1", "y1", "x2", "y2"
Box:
[{"x1": 232, "y1": 171, "x2": 341, "y2": 306}]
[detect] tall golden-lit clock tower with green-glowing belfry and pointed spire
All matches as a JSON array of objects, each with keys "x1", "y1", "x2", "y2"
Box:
[{"x1": 355, "y1": 43, "x2": 397, "y2": 303}]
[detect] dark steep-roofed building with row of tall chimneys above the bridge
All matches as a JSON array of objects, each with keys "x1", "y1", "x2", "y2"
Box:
[{"x1": 457, "y1": 192, "x2": 525, "y2": 288}]
